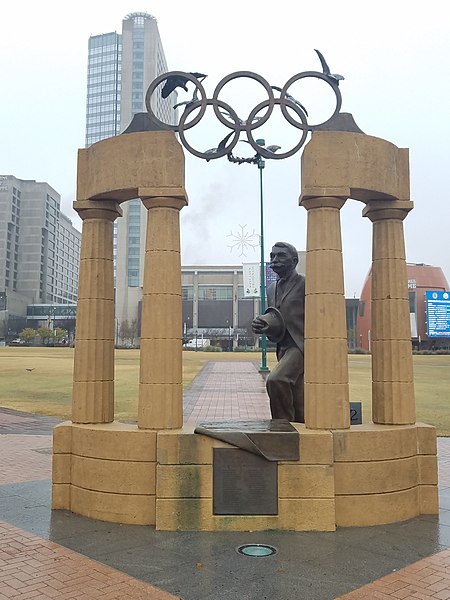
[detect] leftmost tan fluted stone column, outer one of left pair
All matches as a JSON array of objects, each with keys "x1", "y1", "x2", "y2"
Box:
[{"x1": 72, "y1": 200, "x2": 122, "y2": 423}]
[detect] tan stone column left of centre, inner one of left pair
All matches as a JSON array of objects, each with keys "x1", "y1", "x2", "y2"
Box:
[{"x1": 138, "y1": 197, "x2": 187, "y2": 429}]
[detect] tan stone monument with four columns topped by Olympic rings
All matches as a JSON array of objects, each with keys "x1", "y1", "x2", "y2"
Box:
[{"x1": 52, "y1": 61, "x2": 438, "y2": 531}]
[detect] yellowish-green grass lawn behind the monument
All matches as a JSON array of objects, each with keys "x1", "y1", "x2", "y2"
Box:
[{"x1": 0, "y1": 347, "x2": 450, "y2": 436}]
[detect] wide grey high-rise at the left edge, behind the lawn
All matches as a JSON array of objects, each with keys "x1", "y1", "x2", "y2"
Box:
[{"x1": 0, "y1": 175, "x2": 81, "y2": 332}]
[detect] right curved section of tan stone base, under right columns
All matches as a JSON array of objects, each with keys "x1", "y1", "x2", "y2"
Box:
[{"x1": 333, "y1": 423, "x2": 439, "y2": 527}]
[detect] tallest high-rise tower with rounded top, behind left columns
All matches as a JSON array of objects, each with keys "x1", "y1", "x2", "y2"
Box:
[{"x1": 86, "y1": 12, "x2": 176, "y2": 338}]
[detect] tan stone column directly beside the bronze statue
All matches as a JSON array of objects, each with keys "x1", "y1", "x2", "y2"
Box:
[{"x1": 301, "y1": 196, "x2": 350, "y2": 429}]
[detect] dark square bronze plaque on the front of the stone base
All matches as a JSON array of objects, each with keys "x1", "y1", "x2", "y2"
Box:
[{"x1": 213, "y1": 448, "x2": 278, "y2": 515}]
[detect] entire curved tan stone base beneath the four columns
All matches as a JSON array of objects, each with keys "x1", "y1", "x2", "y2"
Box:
[{"x1": 52, "y1": 422, "x2": 439, "y2": 531}]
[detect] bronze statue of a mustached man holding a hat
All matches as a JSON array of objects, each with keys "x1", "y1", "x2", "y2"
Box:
[{"x1": 252, "y1": 242, "x2": 305, "y2": 423}]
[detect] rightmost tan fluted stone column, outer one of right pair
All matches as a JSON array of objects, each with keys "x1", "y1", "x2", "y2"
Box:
[{"x1": 363, "y1": 200, "x2": 415, "y2": 425}]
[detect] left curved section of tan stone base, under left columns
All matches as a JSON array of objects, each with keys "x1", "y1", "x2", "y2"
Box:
[{"x1": 52, "y1": 422, "x2": 156, "y2": 525}]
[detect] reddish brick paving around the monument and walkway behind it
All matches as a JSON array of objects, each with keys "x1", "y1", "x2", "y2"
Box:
[{"x1": 0, "y1": 362, "x2": 450, "y2": 600}]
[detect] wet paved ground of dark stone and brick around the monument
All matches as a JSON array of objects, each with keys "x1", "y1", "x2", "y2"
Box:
[{"x1": 0, "y1": 362, "x2": 450, "y2": 600}]
